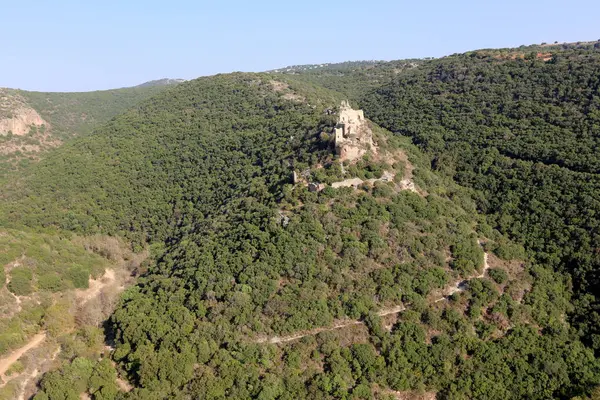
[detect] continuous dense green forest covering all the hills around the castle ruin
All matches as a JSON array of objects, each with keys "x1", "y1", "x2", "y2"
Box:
[{"x1": 0, "y1": 45, "x2": 600, "y2": 400}]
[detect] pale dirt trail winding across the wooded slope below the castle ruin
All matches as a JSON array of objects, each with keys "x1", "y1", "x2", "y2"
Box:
[{"x1": 254, "y1": 253, "x2": 490, "y2": 344}]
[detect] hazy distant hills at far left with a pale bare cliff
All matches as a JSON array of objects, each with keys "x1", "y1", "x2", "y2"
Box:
[{"x1": 0, "y1": 80, "x2": 179, "y2": 179}]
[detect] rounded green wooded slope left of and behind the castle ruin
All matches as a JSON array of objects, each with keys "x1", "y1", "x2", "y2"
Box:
[{"x1": 0, "y1": 75, "x2": 338, "y2": 242}]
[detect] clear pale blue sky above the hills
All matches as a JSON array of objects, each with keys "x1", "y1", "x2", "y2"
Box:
[{"x1": 0, "y1": 0, "x2": 600, "y2": 91}]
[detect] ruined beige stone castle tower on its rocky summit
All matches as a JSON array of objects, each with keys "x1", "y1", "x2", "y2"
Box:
[{"x1": 335, "y1": 101, "x2": 377, "y2": 161}]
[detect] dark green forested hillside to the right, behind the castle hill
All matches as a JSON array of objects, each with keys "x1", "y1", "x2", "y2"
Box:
[{"x1": 362, "y1": 44, "x2": 600, "y2": 353}]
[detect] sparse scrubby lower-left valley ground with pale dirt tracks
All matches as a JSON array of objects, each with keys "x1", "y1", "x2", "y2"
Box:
[{"x1": 0, "y1": 229, "x2": 147, "y2": 400}]
